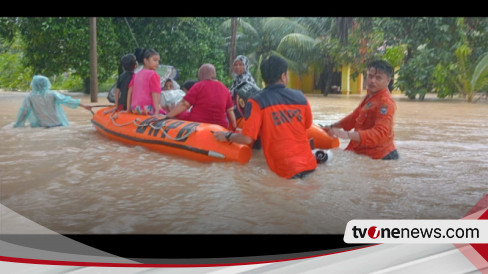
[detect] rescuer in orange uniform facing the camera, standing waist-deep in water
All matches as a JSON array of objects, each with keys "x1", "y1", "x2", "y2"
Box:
[{"x1": 324, "y1": 60, "x2": 399, "y2": 160}]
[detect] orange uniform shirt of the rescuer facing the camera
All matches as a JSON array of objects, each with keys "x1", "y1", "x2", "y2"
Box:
[{"x1": 340, "y1": 88, "x2": 398, "y2": 159}]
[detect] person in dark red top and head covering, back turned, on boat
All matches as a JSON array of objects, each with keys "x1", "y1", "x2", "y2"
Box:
[{"x1": 160, "y1": 64, "x2": 237, "y2": 129}]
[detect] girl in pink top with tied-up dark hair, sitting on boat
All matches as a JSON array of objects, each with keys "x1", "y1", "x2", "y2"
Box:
[{"x1": 127, "y1": 49, "x2": 165, "y2": 115}]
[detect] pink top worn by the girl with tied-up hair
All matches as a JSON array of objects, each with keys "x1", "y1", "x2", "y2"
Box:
[{"x1": 129, "y1": 69, "x2": 161, "y2": 115}]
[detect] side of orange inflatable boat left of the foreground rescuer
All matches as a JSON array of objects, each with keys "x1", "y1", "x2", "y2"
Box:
[{"x1": 91, "y1": 108, "x2": 251, "y2": 164}]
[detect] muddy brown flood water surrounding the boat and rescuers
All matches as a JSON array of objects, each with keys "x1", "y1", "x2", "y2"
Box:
[{"x1": 0, "y1": 92, "x2": 488, "y2": 234}]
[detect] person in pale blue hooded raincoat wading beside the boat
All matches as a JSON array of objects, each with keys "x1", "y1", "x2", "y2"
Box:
[{"x1": 14, "y1": 75, "x2": 91, "y2": 128}]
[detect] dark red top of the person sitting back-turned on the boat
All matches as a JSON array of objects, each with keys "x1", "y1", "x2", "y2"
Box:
[{"x1": 184, "y1": 80, "x2": 234, "y2": 128}]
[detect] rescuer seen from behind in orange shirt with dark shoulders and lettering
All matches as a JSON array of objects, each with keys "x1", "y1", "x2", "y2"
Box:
[{"x1": 214, "y1": 55, "x2": 317, "y2": 179}]
